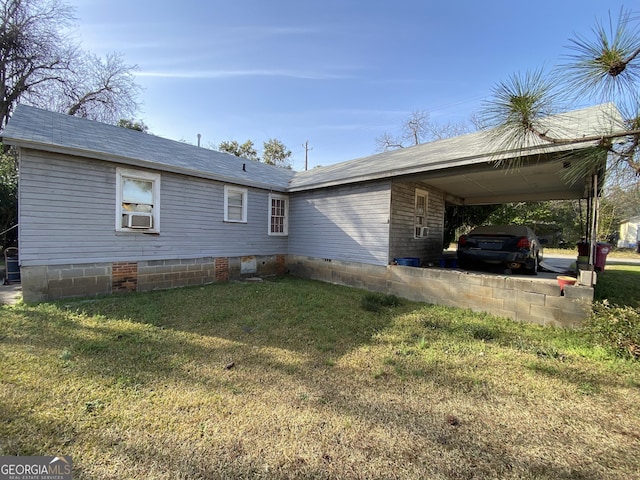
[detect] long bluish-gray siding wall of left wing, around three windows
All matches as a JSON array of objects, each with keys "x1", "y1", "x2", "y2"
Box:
[{"x1": 19, "y1": 149, "x2": 288, "y2": 266}]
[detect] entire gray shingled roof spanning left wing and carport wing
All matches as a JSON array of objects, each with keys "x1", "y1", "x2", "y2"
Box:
[{"x1": 3, "y1": 104, "x2": 623, "y2": 203}]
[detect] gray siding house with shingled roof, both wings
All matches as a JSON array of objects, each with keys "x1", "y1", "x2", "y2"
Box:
[{"x1": 3, "y1": 105, "x2": 619, "y2": 324}]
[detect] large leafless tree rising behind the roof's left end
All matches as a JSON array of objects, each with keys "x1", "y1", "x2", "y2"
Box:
[{"x1": 0, "y1": 0, "x2": 140, "y2": 129}]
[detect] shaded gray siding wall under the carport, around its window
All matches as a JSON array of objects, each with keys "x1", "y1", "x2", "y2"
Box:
[{"x1": 389, "y1": 181, "x2": 444, "y2": 263}]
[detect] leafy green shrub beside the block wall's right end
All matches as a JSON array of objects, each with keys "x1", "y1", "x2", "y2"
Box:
[{"x1": 587, "y1": 300, "x2": 640, "y2": 360}]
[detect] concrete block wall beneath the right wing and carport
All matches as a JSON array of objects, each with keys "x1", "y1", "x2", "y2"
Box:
[{"x1": 288, "y1": 256, "x2": 593, "y2": 327}]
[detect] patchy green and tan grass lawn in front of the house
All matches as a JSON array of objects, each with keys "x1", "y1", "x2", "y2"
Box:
[{"x1": 0, "y1": 276, "x2": 640, "y2": 479}]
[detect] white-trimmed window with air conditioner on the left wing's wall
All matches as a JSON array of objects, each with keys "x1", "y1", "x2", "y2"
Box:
[{"x1": 116, "y1": 167, "x2": 160, "y2": 233}]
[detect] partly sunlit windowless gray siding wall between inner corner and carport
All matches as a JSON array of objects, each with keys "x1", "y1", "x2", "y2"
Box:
[{"x1": 289, "y1": 181, "x2": 391, "y2": 265}]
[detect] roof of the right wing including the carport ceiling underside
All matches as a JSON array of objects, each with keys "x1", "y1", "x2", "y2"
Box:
[{"x1": 289, "y1": 103, "x2": 623, "y2": 205}]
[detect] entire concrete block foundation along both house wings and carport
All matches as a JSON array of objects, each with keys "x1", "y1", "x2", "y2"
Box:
[{"x1": 21, "y1": 255, "x2": 593, "y2": 327}]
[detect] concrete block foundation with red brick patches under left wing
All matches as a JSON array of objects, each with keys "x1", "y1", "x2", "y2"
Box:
[{"x1": 21, "y1": 255, "x2": 286, "y2": 303}]
